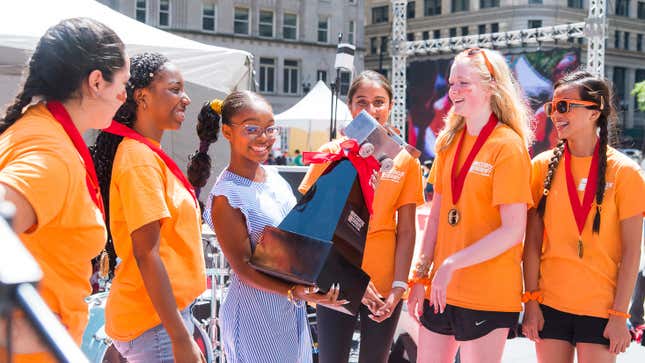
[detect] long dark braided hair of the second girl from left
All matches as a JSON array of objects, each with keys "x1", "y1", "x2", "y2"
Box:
[{"x1": 90, "y1": 53, "x2": 168, "y2": 273}]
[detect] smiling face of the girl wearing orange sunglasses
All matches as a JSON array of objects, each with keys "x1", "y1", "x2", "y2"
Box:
[{"x1": 551, "y1": 84, "x2": 600, "y2": 140}]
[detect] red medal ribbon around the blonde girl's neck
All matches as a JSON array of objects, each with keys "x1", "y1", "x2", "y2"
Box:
[{"x1": 450, "y1": 112, "x2": 498, "y2": 205}]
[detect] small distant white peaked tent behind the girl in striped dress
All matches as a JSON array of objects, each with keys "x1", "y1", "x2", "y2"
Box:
[{"x1": 275, "y1": 81, "x2": 352, "y2": 149}]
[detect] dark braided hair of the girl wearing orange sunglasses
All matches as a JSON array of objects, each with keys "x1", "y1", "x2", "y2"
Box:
[{"x1": 537, "y1": 71, "x2": 616, "y2": 234}]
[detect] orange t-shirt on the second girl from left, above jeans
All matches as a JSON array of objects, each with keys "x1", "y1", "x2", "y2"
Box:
[{"x1": 105, "y1": 138, "x2": 206, "y2": 341}]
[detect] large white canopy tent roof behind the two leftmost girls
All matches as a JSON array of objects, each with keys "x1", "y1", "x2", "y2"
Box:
[{"x1": 0, "y1": 0, "x2": 252, "y2": 93}]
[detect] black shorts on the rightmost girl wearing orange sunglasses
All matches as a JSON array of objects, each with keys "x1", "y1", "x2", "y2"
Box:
[{"x1": 540, "y1": 305, "x2": 609, "y2": 346}]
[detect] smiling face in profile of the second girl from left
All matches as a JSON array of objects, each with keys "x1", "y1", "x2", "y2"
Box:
[{"x1": 144, "y1": 63, "x2": 190, "y2": 130}]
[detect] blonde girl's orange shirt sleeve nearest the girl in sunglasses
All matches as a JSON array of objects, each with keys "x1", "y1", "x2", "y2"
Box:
[{"x1": 492, "y1": 140, "x2": 533, "y2": 208}]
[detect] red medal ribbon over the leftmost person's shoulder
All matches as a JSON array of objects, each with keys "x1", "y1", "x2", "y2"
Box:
[{"x1": 47, "y1": 101, "x2": 105, "y2": 219}]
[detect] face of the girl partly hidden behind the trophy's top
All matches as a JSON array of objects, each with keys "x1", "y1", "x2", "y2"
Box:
[{"x1": 349, "y1": 80, "x2": 392, "y2": 125}]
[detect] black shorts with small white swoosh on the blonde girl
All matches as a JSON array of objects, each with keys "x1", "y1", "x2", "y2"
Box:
[{"x1": 419, "y1": 300, "x2": 520, "y2": 341}]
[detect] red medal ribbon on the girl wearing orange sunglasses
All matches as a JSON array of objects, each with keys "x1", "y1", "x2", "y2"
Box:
[{"x1": 564, "y1": 142, "x2": 600, "y2": 235}]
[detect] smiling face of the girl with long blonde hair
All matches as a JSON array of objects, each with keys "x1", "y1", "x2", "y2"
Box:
[{"x1": 448, "y1": 59, "x2": 490, "y2": 118}]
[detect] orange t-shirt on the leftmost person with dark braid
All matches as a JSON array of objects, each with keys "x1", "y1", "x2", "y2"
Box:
[{"x1": 0, "y1": 104, "x2": 106, "y2": 345}]
